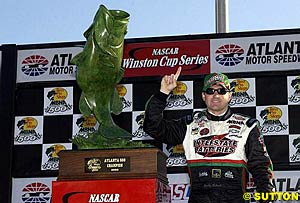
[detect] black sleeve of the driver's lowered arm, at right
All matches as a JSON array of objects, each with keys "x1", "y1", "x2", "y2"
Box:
[{"x1": 245, "y1": 120, "x2": 275, "y2": 197}]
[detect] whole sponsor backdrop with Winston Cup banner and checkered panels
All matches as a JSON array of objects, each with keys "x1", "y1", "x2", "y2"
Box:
[{"x1": 4, "y1": 30, "x2": 300, "y2": 203}]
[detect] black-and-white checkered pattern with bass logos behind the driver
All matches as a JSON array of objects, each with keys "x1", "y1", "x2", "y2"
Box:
[{"x1": 12, "y1": 72, "x2": 300, "y2": 177}]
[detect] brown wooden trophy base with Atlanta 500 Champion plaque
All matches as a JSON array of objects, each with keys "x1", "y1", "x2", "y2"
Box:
[{"x1": 57, "y1": 148, "x2": 168, "y2": 184}]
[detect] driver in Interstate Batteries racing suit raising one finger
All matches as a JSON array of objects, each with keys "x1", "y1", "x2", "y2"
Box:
[{"x1": 143, "y1": 67, "x2": 274, "y2": 203}]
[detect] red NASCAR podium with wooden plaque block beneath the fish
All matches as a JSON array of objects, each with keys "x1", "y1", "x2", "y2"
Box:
[{"x1": 52, "y1": 148, "x2": 171, "y2": 203}]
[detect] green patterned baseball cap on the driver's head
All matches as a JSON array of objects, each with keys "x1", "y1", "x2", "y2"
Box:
[{"x1": 202, "y1": 73, "x2": 230, "y2": 91}]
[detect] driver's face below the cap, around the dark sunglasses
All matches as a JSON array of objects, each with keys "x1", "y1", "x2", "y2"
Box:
[{"x1": 202, "y1": 84, "x2": 232, "y2": 115}]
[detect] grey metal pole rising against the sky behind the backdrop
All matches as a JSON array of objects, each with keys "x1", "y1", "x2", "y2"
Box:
[{"x1": 215, "y1": 0, "x2": 228, "y2": 33}]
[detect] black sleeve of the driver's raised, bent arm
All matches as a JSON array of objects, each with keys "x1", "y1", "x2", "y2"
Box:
[{"x1": 143, "y1": 92, "x2": 187, "y2": 146}]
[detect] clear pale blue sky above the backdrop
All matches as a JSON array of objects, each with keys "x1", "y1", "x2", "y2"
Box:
[{"x1": 0, "y1": 0, "x2": 300, "y2": 45}]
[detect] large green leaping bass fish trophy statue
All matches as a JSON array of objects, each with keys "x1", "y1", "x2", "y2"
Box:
[{"x1": 71, "y1": 5, "x2": 150, "y2": 149}]
